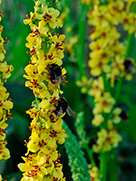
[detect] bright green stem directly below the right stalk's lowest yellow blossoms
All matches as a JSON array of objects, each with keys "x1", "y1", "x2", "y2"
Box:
[{"x1": 100, "y1": 152, "x2": 108, "y2": 181}]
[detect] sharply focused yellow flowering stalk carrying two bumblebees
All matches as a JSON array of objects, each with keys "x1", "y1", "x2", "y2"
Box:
[{"x1": 18, "y1": 0, "x2": 67, "y2": 181}]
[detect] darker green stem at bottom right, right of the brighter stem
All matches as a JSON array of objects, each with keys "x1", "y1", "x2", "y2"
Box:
[{"x1": 109, "y1": 149, "x2": 118, "y2": 181}]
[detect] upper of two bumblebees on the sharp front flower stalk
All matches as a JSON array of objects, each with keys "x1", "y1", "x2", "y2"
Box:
[{"x1": 48, "y1": 63, "x2": 66, "y2": 84}]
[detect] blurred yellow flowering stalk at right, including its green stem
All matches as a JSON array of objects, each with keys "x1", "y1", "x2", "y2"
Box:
[{"x1": 78, "y1": 0, "x2": 136, "y2": 180}]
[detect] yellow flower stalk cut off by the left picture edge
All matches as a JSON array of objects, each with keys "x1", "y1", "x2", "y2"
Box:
[{"x1": 0, "y1": 1, "x2": 13, "y2": 161}]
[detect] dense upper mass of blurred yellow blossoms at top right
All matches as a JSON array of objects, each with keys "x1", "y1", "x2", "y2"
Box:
[{"x1": 88, "y1": 0, "x2": 135, "y2": 84}]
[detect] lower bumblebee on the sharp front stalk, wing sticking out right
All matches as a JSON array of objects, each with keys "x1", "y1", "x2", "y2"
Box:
[{"x1": 54, "y1": 97, "x2": 77, "y2": 117}]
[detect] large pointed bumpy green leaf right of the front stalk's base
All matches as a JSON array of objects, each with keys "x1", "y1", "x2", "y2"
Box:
[{"x1": 63, "y1": 122, "x2": 90, "y2": 181}]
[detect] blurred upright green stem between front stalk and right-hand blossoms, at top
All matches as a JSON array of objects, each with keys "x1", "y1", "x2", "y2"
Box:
[{"x1": 77, "y1": 1, "x2": 88, "y2": 76}]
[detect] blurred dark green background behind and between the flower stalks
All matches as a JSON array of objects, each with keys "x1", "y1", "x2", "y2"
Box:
[{"x1": 0, "y1": 0, "x2": 136, "y2": 181}]
